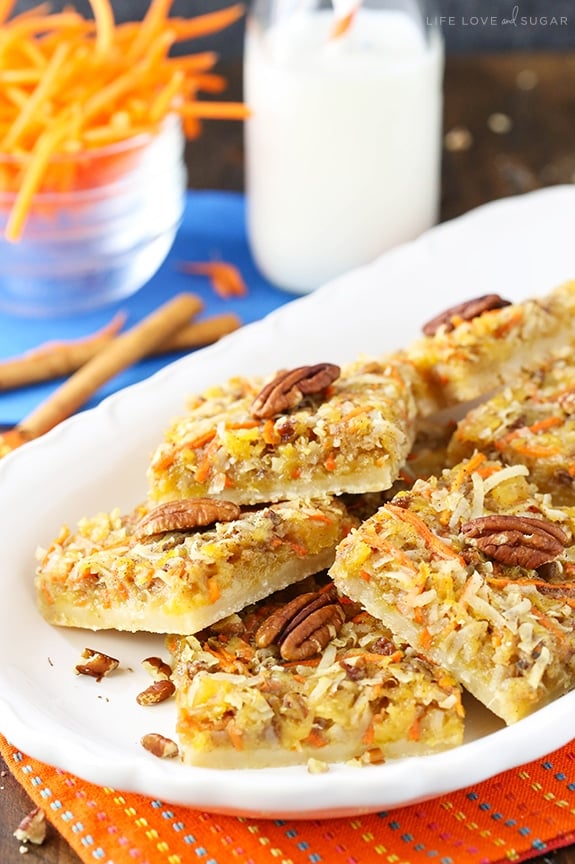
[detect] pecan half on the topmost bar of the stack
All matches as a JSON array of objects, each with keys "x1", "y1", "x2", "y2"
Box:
[{"x1": 251, "y1": 363, "x2": 341, "y2": 420}]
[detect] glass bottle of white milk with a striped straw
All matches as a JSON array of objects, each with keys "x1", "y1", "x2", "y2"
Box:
[{"x1": 244, "y1": 0, "x2": 443, "y2": 293}]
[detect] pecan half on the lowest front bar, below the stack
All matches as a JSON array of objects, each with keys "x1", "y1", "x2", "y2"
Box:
[{"x1": 255, "y1": 589, "x2": 345, "y2": 660}]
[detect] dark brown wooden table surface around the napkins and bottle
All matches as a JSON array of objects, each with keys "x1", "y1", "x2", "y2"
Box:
[{"x1": 0, "y1": 53, "x2": 575, "y2": 864}]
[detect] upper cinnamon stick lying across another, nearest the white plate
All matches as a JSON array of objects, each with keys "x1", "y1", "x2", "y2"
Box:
[{"x1": 15, "y1": 294, "x2": 202, "y2": 441}]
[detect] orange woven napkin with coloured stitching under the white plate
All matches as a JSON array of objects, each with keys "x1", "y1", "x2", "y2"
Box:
[{"x1": 0, "y1": 737, "x2": 575, "y2": 864}]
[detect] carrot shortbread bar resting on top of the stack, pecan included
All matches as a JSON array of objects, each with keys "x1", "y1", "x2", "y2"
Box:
[{"x1": 148, "y1": 359, "x2": 415, "y2": 504}]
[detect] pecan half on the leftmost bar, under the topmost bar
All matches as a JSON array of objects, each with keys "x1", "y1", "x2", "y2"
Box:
[{"x1": 134, "y1": 498, "x2": 242, "y2": 540}]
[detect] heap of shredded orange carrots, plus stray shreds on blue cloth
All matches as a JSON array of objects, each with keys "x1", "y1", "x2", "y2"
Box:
[{"x1": 0, "y1": 0, "x2": 248, "y2": 240}]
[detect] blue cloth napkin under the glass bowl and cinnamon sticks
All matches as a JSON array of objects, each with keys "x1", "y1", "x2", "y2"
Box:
[{"x1": 0, "y1": 191, "x2": 294, "y2": 424}]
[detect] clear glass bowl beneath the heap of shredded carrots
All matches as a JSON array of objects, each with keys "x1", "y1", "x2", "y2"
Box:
[{"x1": 0, "y1": 116, "x2": 187, "y2": 315}]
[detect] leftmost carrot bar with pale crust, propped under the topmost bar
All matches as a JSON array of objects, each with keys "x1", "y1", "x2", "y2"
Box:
[{"x1": 36, "y1": 499, "x2": 355, "y2": 633}]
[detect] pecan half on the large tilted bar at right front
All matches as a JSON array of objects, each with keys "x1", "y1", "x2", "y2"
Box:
[{"x1": 461, "y1": 514, "x2": 569, "y2": 570}]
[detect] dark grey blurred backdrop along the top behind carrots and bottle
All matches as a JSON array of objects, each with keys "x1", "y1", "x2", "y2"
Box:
[{"x1": 9, "y1": 0, "x2": 575, "y2": 53}]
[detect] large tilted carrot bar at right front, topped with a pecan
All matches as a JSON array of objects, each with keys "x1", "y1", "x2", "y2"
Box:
[{"x1": 330, "y1": 454, "x2": 575, "y2": 723}]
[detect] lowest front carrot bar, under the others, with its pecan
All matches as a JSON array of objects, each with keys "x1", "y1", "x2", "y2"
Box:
[{"x1": 170, "y1": 585, "x2": 463, "y2": 770}]
